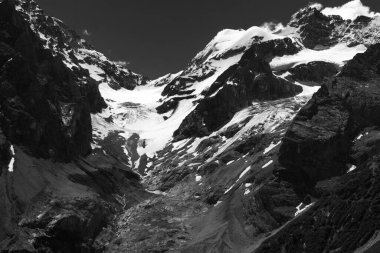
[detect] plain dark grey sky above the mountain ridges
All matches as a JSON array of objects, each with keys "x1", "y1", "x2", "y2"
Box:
[{"x1": 37, "y1": 0, "x2": 380, "y2": 78}]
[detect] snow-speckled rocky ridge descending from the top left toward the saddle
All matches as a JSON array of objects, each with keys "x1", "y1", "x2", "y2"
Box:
[{"x1": 15, "y1": 0, "x2": 148, "y2": 89}]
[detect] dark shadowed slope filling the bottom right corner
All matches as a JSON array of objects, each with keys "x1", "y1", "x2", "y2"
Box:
[{"x1": 255, "y1": 154, "x2": 380, "y2": 253}]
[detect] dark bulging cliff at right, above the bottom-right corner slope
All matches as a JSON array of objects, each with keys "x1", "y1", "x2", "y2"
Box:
[{"x1": 279, "y1": 44, "x2": 380, "y2": 197}]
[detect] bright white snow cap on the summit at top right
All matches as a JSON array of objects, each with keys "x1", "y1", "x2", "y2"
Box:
[{"x1": 322, "y1": 0, "x2": 380, "y2": 20}]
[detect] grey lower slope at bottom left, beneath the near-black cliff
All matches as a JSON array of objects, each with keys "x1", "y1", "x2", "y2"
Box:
[{"x1": 0, "y1": 148, "x2": 147, "y2": 252}]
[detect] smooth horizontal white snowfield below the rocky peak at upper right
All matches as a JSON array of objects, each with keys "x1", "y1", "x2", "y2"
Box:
[{"x1": 270, "y1": 44, "x2": 367, "y2": 70}]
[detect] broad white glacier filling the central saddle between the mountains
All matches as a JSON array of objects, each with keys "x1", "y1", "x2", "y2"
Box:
[{"x1": 92, "y1": 83, "x2": 194, "y2": 156}]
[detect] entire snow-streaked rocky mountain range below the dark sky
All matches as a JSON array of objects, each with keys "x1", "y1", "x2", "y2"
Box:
[{"x1": 0, "y1": 0, "x2": 380, "y2": 253}]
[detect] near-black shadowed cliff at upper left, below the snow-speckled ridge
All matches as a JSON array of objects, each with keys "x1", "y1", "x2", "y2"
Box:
[{"x1": 0, "y1": 1, "x2": 105, "y2": 161}]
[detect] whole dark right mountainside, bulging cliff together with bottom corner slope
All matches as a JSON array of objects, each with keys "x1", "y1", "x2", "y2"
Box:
[{"x1": 256, "y1": 44, "x2": 380, "y2": 252}]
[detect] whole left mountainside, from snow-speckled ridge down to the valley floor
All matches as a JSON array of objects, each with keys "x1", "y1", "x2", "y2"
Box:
[{"x1": 0, "y1": 0, "x2": 148, "y2": 252}]
